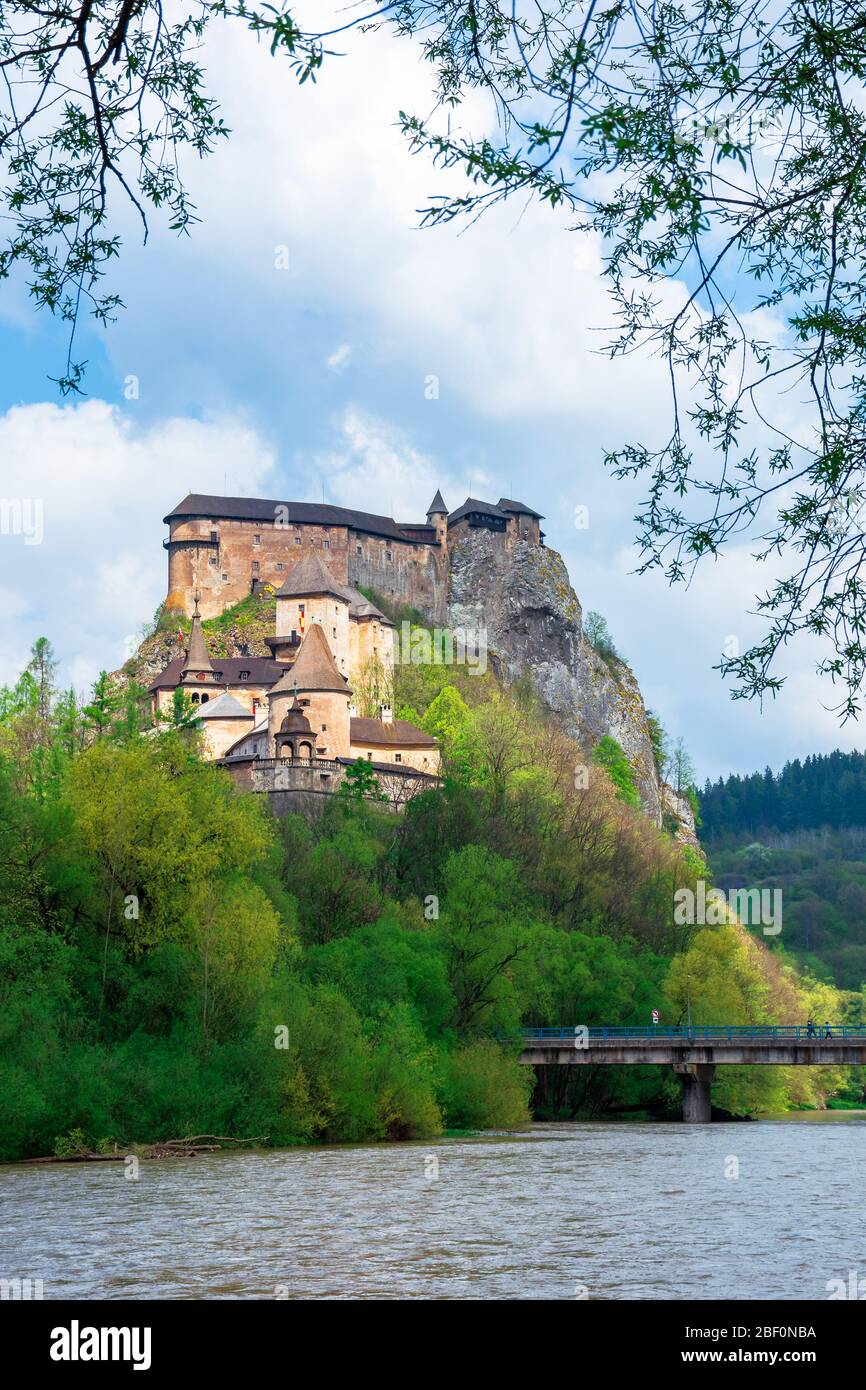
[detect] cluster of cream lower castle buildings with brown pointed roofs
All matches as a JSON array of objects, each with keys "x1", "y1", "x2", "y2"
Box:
[{"x1": 150, "y1": 552, "x2": 439, "y2": 792}]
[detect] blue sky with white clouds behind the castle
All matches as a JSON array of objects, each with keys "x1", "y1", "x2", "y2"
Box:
[{"x1": 0, "y1": 16, "x2": 860, "y2": 781}]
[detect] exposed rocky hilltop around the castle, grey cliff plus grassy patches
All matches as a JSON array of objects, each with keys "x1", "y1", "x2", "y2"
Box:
[{"x1": 118, "y1": 530, "x2": 698, "y2": 847}]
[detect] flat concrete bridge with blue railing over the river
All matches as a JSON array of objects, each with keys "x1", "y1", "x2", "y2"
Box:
[{"x1": 520, "y1": 1023, "x2": 866, "y2": 1125}]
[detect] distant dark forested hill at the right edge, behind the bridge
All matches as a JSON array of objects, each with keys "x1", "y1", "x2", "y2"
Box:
[{"x1": 701, "y1": 751, "x2": 866, "y2": 990}]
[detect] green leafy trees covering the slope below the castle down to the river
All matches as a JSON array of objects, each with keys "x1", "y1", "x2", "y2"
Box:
[{"x1": 0, "y1": 641, "x2": 863, "y2": 1159}]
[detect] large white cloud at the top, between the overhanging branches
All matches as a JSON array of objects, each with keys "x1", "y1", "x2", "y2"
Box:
[{"x1": 157, "y1": 17, "x2": 676, "y2": 424}]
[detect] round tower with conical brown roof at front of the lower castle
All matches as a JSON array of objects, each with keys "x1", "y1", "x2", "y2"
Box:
[{"x1": 268, "y1": 623, "x2": 352, "y2": 758}]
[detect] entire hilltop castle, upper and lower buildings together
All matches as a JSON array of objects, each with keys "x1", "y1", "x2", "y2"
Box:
[{"x1": 150, "y1": 492, "x2": 544, "y2": 799}]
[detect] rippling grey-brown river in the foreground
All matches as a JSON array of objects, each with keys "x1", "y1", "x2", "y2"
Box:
[{"x1": 0, "y1": 1112, "x2": 866, "y2": 1300}]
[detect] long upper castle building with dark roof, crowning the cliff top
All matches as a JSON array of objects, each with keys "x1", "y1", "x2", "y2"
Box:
[{"x1": 163, "y1": 492, "x2": 544, "y2": 624}]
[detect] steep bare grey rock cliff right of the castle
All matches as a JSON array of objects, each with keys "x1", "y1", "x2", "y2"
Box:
[{"x1": 449, "y1": 530, "x2": 695, "y2": 840}]
